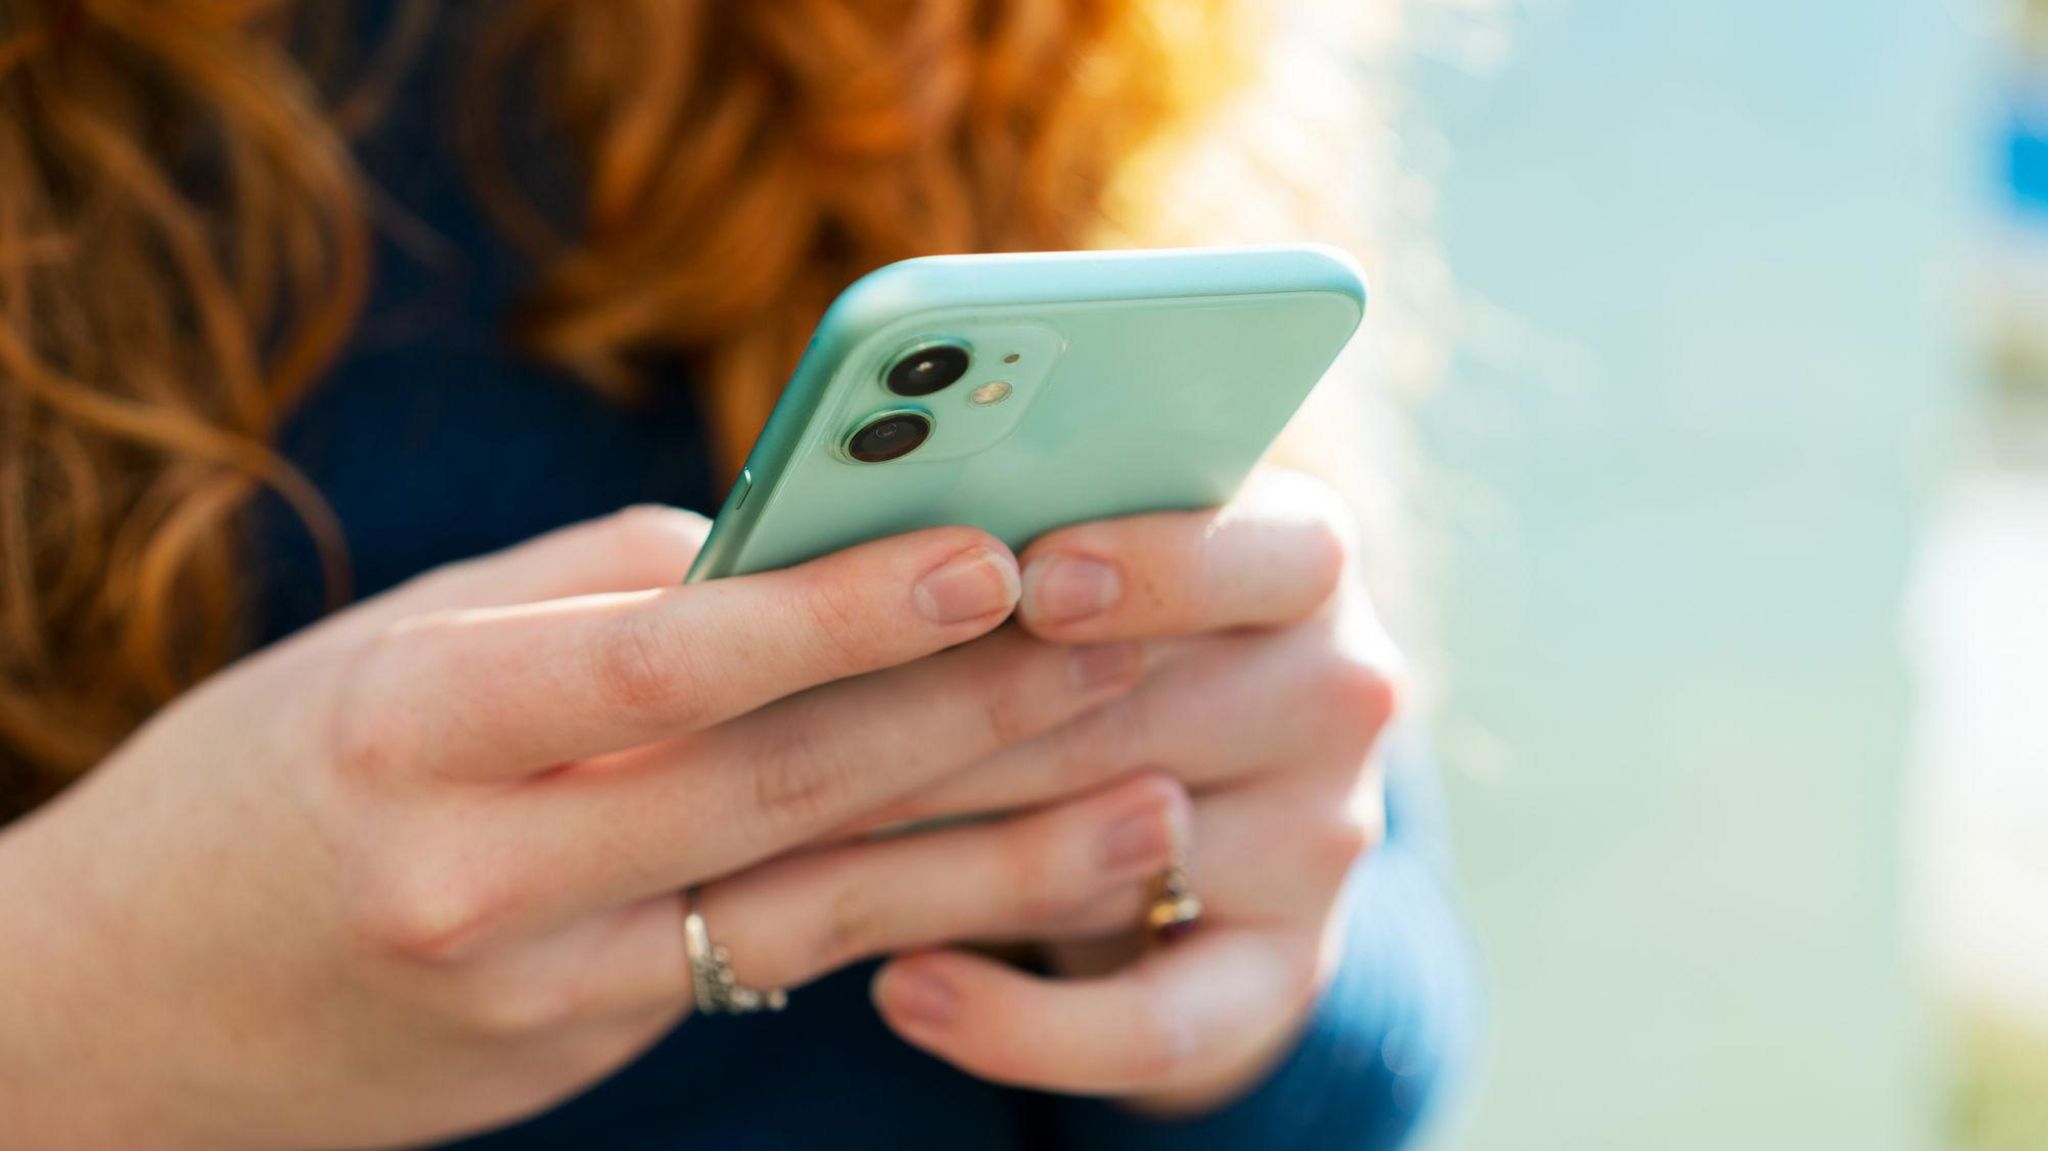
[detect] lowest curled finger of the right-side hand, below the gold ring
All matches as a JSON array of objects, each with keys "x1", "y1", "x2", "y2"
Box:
[{"x1": 874, "y1": 930, "x2": 1317, "y2": 1096}]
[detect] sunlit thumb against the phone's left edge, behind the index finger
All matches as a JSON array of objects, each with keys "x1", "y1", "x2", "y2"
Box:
[{"x1": 321, "y1": 504, "x2": 711, "y2": 631}]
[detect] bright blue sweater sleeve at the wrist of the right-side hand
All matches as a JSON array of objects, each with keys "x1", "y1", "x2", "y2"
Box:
[{"x1": 1049, "y1": 745, "x2": 1479, "y2": 1151}]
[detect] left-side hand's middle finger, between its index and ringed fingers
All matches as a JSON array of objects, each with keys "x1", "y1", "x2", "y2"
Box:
[{"x1": 504, "y1": 629, "x2": 1145, "y2": 920}]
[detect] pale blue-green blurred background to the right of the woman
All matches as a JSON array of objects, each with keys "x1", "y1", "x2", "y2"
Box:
[{"x1": 1380, "y1": 0, "x2": 2048, "y2": 1151}]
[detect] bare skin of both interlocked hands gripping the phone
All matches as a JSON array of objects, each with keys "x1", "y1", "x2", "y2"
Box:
[{"x1": 0, "y1": 460, "x2": 1397, "y2": 1149}]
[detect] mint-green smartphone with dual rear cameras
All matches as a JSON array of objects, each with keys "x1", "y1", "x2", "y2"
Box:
[{"x1": 688, "y1": 246, "x2": 1366, "y2": 582}]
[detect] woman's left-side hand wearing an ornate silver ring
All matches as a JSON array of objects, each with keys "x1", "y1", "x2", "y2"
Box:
[{"x1": 0, "y1": 510, "x2": 1187, "y2": 1149}]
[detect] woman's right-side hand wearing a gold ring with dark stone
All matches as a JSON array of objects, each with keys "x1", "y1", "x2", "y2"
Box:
[{"x1": 874, "y1": 471, "x2": 1401, "y2": 1112}]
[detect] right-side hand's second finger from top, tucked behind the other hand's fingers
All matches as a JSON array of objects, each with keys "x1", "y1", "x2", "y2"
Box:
[{"x1": 870, "y1": 608, "x2": 1401, "y2": 825}]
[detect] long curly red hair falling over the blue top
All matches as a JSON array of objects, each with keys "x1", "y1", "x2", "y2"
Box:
[{"x1": 0, "y1": 0, "x2": 1376, "y2": 817}]
